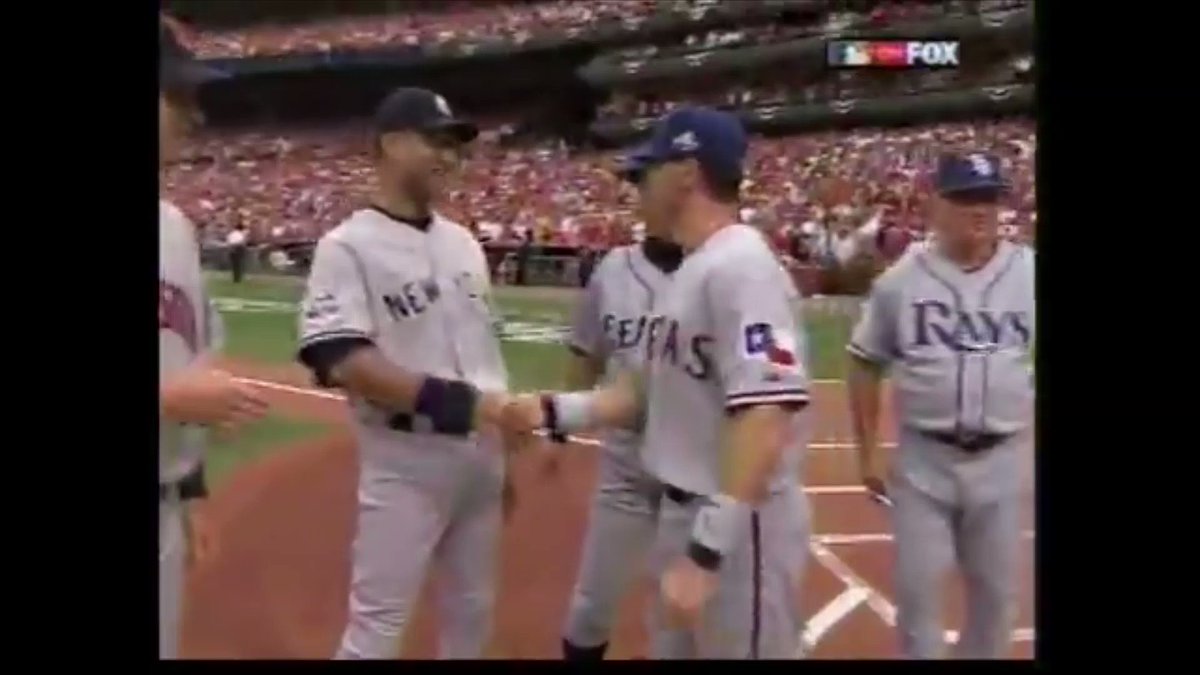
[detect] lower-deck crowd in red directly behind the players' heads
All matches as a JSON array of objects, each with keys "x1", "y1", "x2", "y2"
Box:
[{"x1": 166, "y1": 120, "x2": 1036, "y2": 258}]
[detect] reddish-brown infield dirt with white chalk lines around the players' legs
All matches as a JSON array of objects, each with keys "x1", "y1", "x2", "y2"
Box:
[{"x1": 182, "y1": 364, "x2": 1033, "y2": 658}]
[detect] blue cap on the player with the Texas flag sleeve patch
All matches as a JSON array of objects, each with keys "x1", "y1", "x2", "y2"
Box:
[{"x1": 620, "y1": 106, "x2": 748, "y2": 183}]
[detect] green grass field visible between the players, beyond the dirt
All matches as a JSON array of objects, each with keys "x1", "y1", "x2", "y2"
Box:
[{"x1": 209, "y1": 269, "x2": 853, "y2": 484}]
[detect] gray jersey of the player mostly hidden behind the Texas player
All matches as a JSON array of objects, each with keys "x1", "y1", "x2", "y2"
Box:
[{"x1": 570, "y1": 244, "x2": 670, "y2": 458}]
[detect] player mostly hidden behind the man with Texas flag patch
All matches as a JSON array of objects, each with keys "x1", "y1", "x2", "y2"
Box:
[{"x1": 563, "y1": 156, "x2": 683, "y2": 661}]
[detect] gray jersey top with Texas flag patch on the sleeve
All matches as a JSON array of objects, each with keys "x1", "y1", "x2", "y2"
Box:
[{"x1": 643, "y1": 225, "x2": 809, "y2": 495}]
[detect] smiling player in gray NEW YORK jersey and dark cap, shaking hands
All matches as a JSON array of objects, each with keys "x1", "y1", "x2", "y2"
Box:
[{"x1": 299, "y1": 89, "x2": 508, "y2": 658}]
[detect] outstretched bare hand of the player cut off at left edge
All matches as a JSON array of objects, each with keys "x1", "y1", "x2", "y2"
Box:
[{"x1": 158, "y1": 363, "x2": 268, "y2": 432}]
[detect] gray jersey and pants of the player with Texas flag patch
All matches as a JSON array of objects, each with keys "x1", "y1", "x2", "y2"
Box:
[{"x1": 642, "y1": 225, "x2": 809, "y2": 658}]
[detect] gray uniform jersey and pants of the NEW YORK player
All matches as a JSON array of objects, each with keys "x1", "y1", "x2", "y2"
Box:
[{"x1": 300, "y1": 209, "x2": 508, "y2": 658}]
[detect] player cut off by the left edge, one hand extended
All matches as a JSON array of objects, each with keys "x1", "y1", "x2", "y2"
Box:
[{"x1": 158, "y1": 22, "x2": 266, "y2": 658}]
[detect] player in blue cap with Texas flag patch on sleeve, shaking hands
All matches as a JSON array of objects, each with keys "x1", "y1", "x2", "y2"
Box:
[{"x1": 508, "y1": 107, "x2": 809, "y2": 658}]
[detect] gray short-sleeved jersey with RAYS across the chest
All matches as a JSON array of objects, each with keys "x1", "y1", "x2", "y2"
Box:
[{"x1": 847, "y1": 241, "x2": 1036, "y2": 434}]
